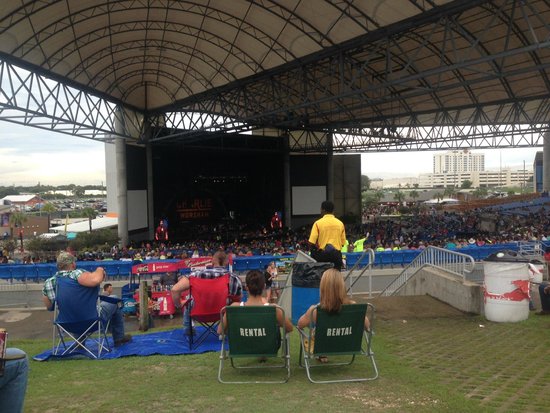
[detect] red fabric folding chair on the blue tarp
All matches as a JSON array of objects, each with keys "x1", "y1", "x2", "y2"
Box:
[{"x1": 184, "y1": 274, "x2": 230, "y2": 349}]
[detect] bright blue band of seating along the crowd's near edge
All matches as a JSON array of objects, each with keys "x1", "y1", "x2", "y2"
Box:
[{"x1": 0, "y1": 243, "x2": 519, "y2": 282}]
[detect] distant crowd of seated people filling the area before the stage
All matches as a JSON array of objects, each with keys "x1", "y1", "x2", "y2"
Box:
[{"x1": 0, "y1": 200, "x2": 550, "y2": 264}]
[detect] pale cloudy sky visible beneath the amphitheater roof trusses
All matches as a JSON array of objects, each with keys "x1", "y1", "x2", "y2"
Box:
[{"x1": 0, "y1": 121, "x2": 542, "y2": 186}]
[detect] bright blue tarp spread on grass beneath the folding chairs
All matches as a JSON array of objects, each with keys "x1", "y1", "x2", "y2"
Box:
[{"x1": 33, "y1": 327, "x2": 221, "y2": 361}]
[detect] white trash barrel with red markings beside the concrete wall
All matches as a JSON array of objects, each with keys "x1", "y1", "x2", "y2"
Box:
[{"x1": 483, "y1": 250, "x2": 530, "y2": 323}]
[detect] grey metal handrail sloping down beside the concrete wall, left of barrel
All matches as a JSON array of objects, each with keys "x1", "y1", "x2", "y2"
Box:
[{"x1": 380, "y1": 247, "x2": 475, "y2": 297}]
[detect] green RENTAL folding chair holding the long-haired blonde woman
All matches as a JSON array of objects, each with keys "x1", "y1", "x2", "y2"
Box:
[{"x1": 298, "y1": 304, "x2": 378, "y2": 383}]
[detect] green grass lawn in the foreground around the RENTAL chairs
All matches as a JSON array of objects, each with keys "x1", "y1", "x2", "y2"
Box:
[{"x1": 17, "y1": 310, "x2": 550, "y2": 413}]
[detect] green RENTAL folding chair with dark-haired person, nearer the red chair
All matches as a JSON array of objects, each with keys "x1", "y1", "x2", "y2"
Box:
[{"x1": 218, "y1": 305, "x2": 290, "y2": 384}]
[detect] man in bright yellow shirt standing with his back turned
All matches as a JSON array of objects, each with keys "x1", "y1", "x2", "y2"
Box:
[{"x1": 309, "y1": 201, "x2": 346, "y2": 270}]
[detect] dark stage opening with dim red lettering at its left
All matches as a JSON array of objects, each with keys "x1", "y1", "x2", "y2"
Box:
[{"x1": 153, "y1": 138, "x2": 284, "y2": 240}]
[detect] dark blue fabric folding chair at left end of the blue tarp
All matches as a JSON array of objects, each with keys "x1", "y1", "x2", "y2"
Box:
[{"x1": 52, "y1": 277, "x2": 112, "y2": 358}]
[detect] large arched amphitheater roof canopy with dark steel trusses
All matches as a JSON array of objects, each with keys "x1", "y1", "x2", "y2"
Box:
[{"x1": 0, "y1": 0, "x2": 550, "y2": 150}]
